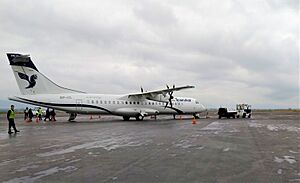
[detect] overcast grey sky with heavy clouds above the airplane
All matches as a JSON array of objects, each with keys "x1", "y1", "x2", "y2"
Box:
[{"x1": 0, "y1": 0, "x2": 299, "y2": 108}]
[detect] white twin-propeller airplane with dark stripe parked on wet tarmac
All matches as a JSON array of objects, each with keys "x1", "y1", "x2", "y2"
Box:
[{"x1": 7, "y1": 53, "x2": 206, "y2": 121}]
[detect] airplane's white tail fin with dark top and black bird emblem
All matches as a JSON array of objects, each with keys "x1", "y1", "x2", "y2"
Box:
[{"x1": 7, "y1": 53, "x2": 84, "y2": 95}]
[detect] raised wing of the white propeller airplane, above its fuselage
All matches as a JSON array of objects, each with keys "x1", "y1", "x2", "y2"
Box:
[{"x1": 121, "y1": 85, "x2": 195, "y2": 98}]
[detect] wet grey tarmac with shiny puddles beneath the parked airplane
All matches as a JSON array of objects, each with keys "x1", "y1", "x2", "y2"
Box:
[{"x1": 0, "y1": 112, "x2": 300, "y2": 183}]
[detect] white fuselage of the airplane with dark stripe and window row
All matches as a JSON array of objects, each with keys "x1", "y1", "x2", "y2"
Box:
[{"x1": 10, "y1": 93, "x2": 205, "y2": 117}]
